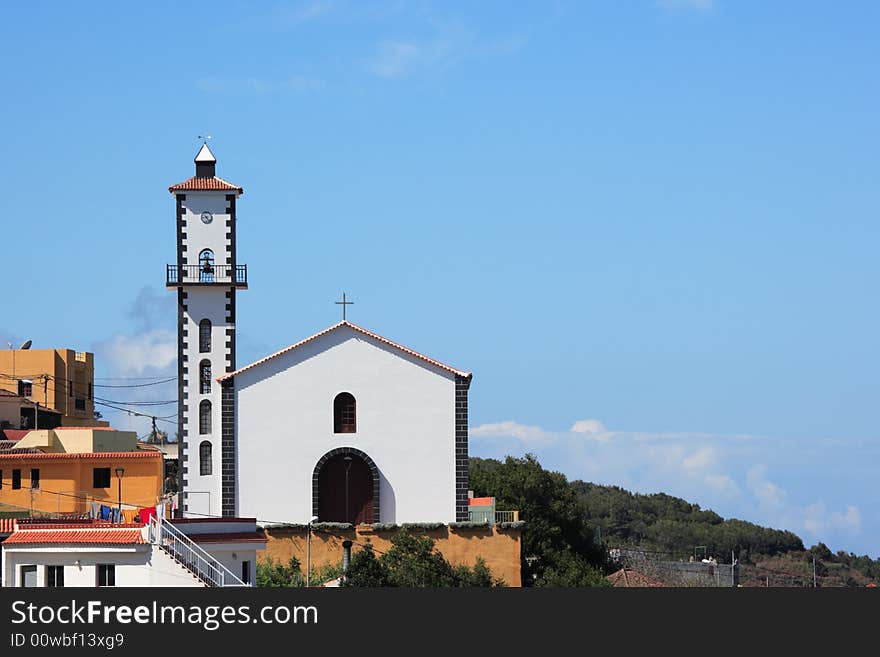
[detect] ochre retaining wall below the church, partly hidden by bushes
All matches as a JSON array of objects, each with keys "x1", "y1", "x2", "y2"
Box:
[{"x1": 257, "y1": 525, "x2": 522, "y2": 586}]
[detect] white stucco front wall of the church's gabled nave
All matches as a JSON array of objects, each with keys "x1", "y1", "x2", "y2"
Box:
[{"x1": 235, "y1": 326, "x2": 455, "y2": 523}]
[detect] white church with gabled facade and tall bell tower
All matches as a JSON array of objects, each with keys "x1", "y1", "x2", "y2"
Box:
[{"x1": 166, "y1": 143, "x2": 472, "y2": 524}]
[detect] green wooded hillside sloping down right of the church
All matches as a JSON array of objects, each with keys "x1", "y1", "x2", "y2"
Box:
[{"x1": 470, "y1": 454, "x2": 880, "y2": 586}]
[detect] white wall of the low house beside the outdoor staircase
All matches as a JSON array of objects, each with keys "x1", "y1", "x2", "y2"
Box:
[{"x1": 3, "y1": 545, "x2": 205, "y2": 588}]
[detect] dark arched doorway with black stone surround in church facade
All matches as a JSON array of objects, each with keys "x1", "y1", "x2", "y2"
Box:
[{"x1": 312, "y1": 447, "x2": 379, "y2": 525}]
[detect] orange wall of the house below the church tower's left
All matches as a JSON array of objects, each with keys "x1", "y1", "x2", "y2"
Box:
[{"x1": 0, "y1": 452, "x2": 163, "y2": 513}]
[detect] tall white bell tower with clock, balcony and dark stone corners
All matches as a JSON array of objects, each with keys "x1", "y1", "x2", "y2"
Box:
[{"x1": 165, "y1": 143, "x2": 247, "y2": 518}]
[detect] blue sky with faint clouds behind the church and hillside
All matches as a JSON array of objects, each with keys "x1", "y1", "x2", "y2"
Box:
[{"x1": 0, "y1": 0, "x2": 880, "y2": 557}]
